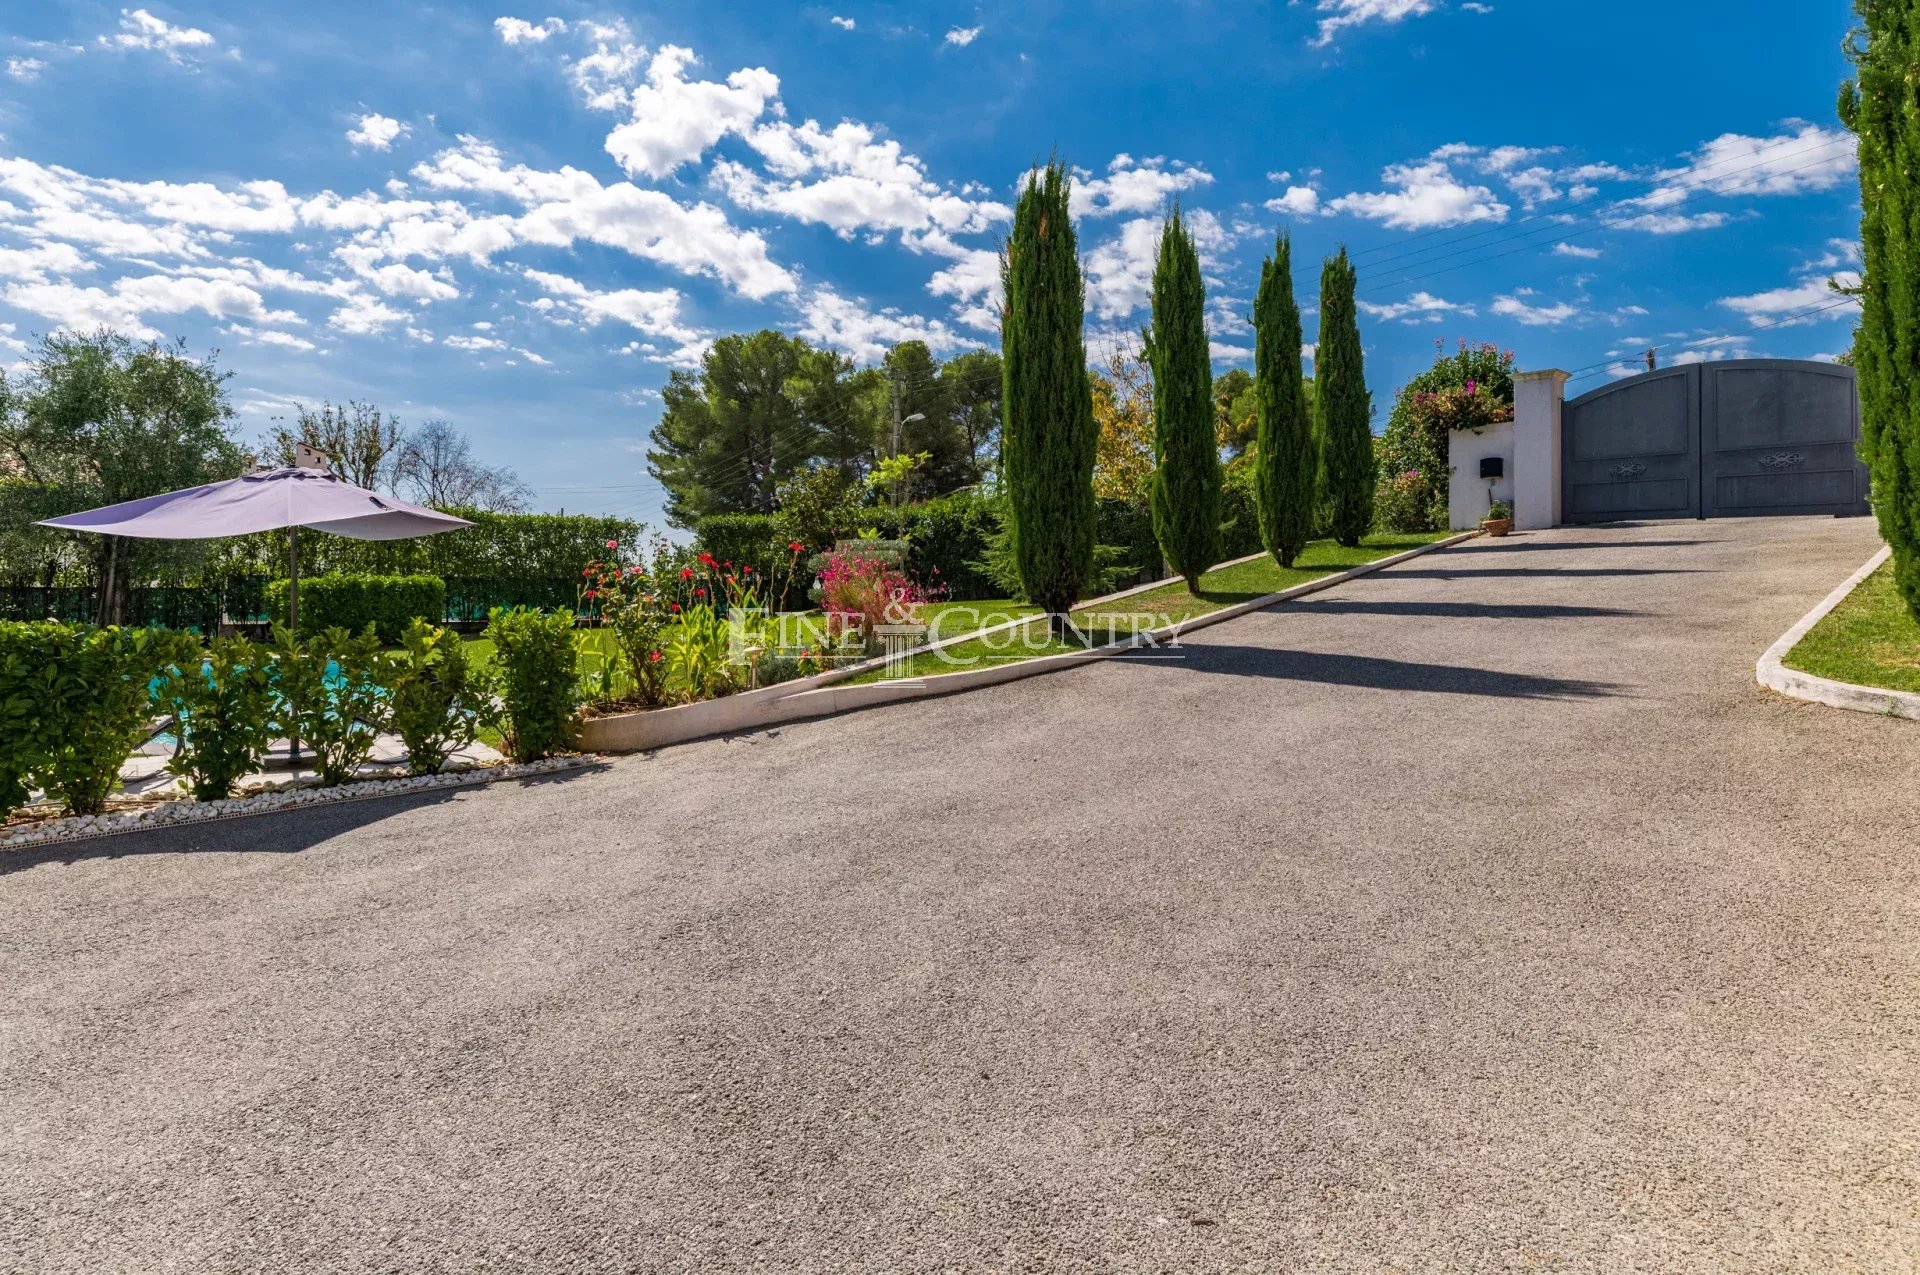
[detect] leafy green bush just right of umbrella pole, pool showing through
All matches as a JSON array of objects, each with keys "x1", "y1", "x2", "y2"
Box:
[{"x1": 275, "y1": 616, "x2": 395, "y2": 783}]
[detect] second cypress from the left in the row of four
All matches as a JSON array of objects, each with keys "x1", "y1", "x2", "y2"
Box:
[{"x1": 1146, "y1": 207, "x2": 1221, "y2": 589}]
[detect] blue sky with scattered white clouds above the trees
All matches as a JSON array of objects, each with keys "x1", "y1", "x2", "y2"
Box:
[{"x1": 0, "y1": 0, "x2": 1859, "y2": 522}]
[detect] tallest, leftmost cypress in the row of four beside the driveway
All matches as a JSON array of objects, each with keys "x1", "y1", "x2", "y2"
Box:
[{"x1": 1000, "y1": 159, "x2": 1098, "y2": 632}]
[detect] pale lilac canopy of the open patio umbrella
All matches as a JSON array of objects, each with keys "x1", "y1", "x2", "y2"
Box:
[{"x1": 36, "y1": 469, "x2": 472, "y2": 540}]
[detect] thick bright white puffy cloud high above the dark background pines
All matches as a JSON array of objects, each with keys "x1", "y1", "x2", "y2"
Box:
[{"x1": 607, "y1": 44, "x2": 781, "y2": 177}]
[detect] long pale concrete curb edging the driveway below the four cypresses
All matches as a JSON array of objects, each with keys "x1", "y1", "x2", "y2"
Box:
[{"x1": 580, "y1": 530, "x2": 1480, "y2": 753}]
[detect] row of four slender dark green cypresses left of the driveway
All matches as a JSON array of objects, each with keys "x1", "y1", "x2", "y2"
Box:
[{"x1": 1000, "y1": 159, "x2": 1375, "y2": 630}]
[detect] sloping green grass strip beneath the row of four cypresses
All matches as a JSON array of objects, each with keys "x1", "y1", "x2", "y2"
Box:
[{"x1": 849, "y1": 532, "x2": 1453, "y2": 686}]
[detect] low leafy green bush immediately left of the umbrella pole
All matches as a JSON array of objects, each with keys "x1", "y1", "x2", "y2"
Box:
[{"x1": 154, "y1": 638, "x2": 280, "y2": 801}]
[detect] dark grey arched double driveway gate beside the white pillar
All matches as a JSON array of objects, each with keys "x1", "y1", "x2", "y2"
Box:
[{"x1": 1561, "y1": 359, "x2": 1868, "y2": 522}]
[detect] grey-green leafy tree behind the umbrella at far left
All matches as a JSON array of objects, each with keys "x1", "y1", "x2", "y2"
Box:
[{"x1": 0, "y1": 330, "x2": 246, "y2": 624}]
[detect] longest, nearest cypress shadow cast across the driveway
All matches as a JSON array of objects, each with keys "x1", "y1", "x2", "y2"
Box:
[{"x1": 1144, "y1": 645, "x2": 1626, "y2": 699}]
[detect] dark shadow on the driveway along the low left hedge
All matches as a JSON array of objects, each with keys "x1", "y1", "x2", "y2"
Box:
[{"x1": 0, "y1": 764, "x2": 607, "y2": 878}]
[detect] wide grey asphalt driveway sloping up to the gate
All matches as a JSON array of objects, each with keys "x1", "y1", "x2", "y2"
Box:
[{"x1": 0, "y1": 518, "x2": 1920, "y2": 1271}]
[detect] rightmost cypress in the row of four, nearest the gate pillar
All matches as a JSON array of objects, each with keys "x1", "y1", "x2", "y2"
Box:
[{"x1": 1313, "y1": 248, "x2": 1375, "y2": 549}]
